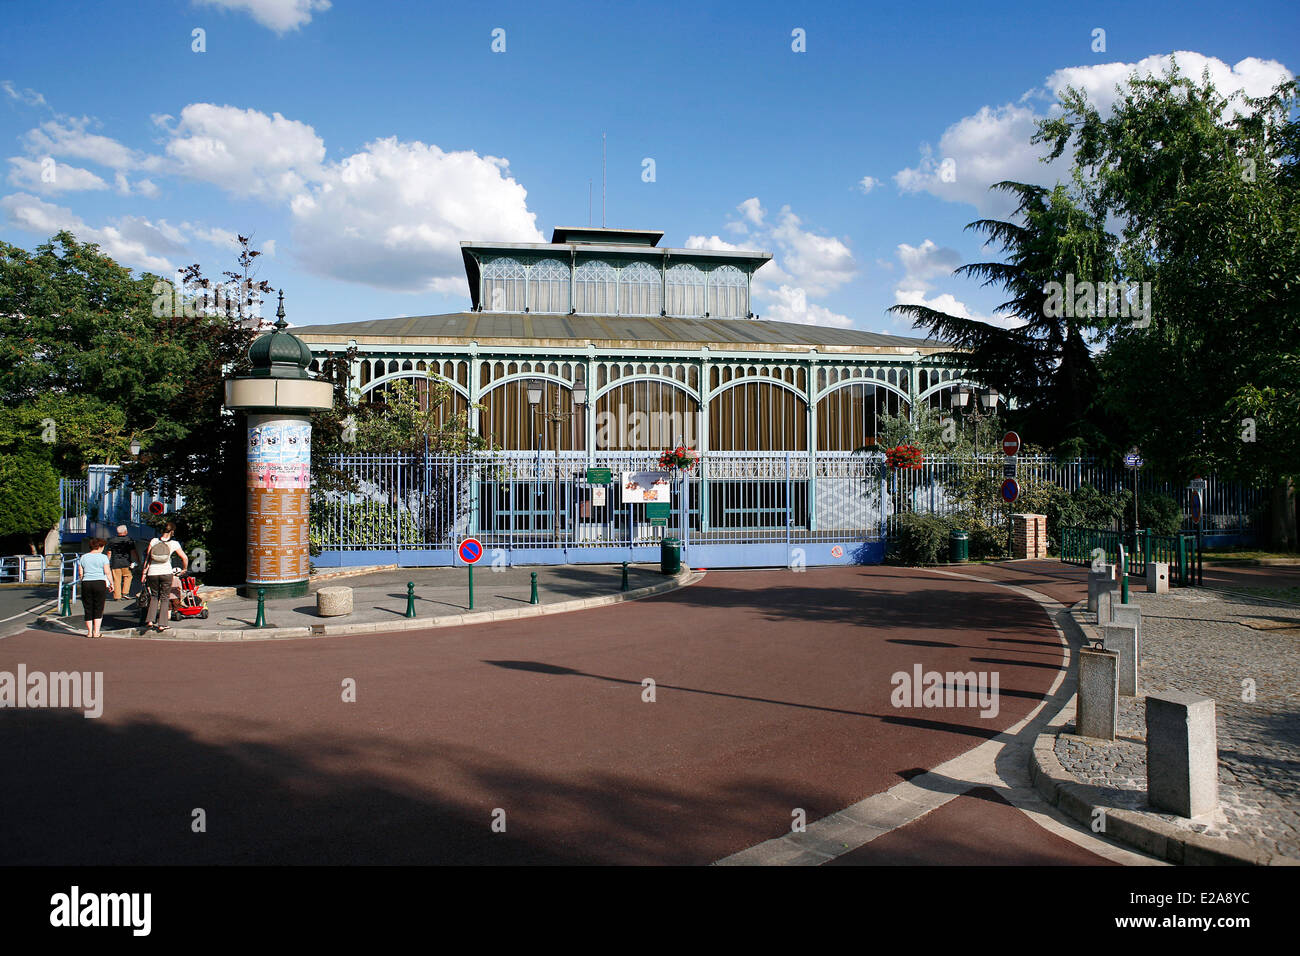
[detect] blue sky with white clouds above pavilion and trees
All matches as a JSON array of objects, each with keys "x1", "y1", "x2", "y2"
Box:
[{"x1": 0, "y1": 0, "x2": 1300, "y2": 334}]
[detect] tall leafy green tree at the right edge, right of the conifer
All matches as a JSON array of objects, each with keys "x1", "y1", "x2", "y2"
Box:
[{"x1": 1035, "y1": 64, "x2": 1300, "y2": 548}]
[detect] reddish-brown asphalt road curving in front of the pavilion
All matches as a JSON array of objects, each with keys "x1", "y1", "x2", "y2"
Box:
[{"x1": 0, "y1": 562, "x2": 1101, "y2": 864}]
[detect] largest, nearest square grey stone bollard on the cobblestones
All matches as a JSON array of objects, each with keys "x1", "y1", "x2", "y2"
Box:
[{"x1": 1147, "y1": 691, "x2": 1218, "y2": 817}]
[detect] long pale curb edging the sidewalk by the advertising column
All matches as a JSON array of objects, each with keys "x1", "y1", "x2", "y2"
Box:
[{"x1": 71, "y1": 568, "x2": 705, "y2": 644}]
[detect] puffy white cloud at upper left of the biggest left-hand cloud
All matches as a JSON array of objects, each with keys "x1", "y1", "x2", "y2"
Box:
[{"x1": 159, "y1": 103, "x2": 325, "y2": 199}]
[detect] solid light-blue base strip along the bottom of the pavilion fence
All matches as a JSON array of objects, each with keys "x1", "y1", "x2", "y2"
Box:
[{"x1": 312, "y1": 541, "x2": 885, "y2": 570}]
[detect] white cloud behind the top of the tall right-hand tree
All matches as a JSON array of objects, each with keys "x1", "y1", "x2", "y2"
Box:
[{"x1": 893, "y1": 51, "x2": 1291, "y2": 217}]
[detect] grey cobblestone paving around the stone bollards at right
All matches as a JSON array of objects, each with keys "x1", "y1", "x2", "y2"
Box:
[{"x1": 1056, "y1": 588, "x2": 1300, "y2": 858}]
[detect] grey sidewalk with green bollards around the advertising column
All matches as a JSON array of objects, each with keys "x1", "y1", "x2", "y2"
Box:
[{"x1": 44, "y1": 564, "x2": 679, "y2": 640}]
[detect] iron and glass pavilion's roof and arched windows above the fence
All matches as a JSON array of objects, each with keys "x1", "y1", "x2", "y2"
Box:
[{"x1": 294, "y1": 226, "x2": 962, "y2": 458}]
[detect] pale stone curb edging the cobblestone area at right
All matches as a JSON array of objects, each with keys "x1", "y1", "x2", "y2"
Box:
[{"x1": 1030, "y1": 601, "x2": 1300, "y2": 866}]
